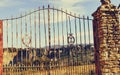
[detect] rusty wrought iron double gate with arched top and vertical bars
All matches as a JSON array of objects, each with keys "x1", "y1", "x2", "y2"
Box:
[{"x1": 3, "y1": 6, "x2": 95, "y2": 75}]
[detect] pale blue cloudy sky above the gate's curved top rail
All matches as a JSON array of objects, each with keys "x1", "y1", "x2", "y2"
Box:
[{"x1": 0, "y1": 0, "x2": 120, "y2": 19}]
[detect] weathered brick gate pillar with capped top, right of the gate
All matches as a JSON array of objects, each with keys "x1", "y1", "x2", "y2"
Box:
[{"x1": 92, "y1": 0, "x2": 120, "y2": 75}]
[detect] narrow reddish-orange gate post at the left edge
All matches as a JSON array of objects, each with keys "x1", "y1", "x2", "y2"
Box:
[{"x1": 0, "y1": 20, "x2": 3, "y2": 75}]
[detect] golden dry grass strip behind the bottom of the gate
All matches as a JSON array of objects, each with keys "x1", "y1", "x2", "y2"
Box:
[{"x1": 3, "y1": 65, "x2": 95, "y2": 75}]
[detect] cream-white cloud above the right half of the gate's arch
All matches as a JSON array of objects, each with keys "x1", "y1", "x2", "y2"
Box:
[{"x1": 49, "y1": 0, "x2": 95, "y2": 15}]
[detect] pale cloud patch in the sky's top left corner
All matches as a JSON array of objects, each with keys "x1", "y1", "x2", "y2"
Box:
[{"x1": 0, "y1": 0, "x2": 22, "y2": 7}]
